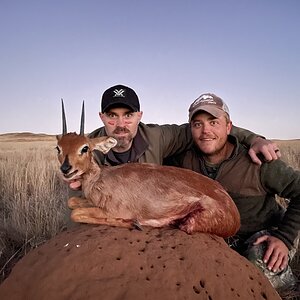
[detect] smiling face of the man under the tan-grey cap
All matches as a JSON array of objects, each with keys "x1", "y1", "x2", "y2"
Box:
[{"x1": 191, "y1": 111, "x2": 232, "y2": 156}]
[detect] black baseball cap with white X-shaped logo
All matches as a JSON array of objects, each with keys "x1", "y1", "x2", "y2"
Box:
[{"x1": 101, "y1": 84, "x2": 140, "y2": 113}]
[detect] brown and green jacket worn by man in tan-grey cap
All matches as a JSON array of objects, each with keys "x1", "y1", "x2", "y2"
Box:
[{"x1": 173, "y1": 136, "x2": 300, "y2": 249}]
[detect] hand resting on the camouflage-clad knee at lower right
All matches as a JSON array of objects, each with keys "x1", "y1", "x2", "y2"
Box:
[{"x1": 253, "y1": 235, "x2": 289, "y2": 272}]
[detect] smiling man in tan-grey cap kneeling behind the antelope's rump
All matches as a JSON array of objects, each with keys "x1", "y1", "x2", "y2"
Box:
[{"x1": 169, "y1": 94, "x2": 300, "y2": 292}]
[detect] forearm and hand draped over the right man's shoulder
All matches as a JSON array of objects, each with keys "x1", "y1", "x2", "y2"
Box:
[{"x1": 231, "y1": 126, "x2": 281, "y2": 165}]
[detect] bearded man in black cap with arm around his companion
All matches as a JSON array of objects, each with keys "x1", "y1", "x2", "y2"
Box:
[{"x1": 89, "y1": 85, "x2": 280, "y2": 165}]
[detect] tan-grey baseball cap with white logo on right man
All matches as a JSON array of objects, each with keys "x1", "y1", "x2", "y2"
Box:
[{"x1": 189, "y1": 93, "x2": 229, "y2": 122}]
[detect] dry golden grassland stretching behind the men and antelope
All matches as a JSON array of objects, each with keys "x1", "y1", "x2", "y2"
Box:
[{"x1": 0, "y1": 133, "x2": 300, "y2": 292}]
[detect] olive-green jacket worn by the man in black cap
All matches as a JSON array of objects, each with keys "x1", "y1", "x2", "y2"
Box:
[{"x1": 89, "y1": 123, "x2": 257, "y2": 165}]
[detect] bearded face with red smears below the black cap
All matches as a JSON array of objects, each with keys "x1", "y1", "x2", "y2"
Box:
[{"x1": 99, "y1": 107, "x2": 143, "y2": 152}]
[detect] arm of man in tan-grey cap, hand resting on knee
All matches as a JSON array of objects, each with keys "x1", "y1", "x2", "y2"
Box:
[{"x1": 254, "y1": 160, "x2": 300, "y2": 272}]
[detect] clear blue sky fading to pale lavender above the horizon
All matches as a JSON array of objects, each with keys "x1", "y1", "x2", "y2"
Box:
[{"x1": 0, "y1": 0, "x2": 300, "y2": 139}]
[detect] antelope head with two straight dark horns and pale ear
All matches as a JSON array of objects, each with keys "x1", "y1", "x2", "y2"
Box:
[{"x1": 56, "y1": 100, "x2": 117, "y2": 182}]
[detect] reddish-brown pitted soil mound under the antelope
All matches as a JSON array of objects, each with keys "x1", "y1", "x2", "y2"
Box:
[{"x1": 0, "y1": 225, "x2": 280, "y2": 300}]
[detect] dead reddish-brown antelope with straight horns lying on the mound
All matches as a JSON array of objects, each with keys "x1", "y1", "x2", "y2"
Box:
[{"x1": 57, "y1": 101, "x2": 240, "y2": 238}]
